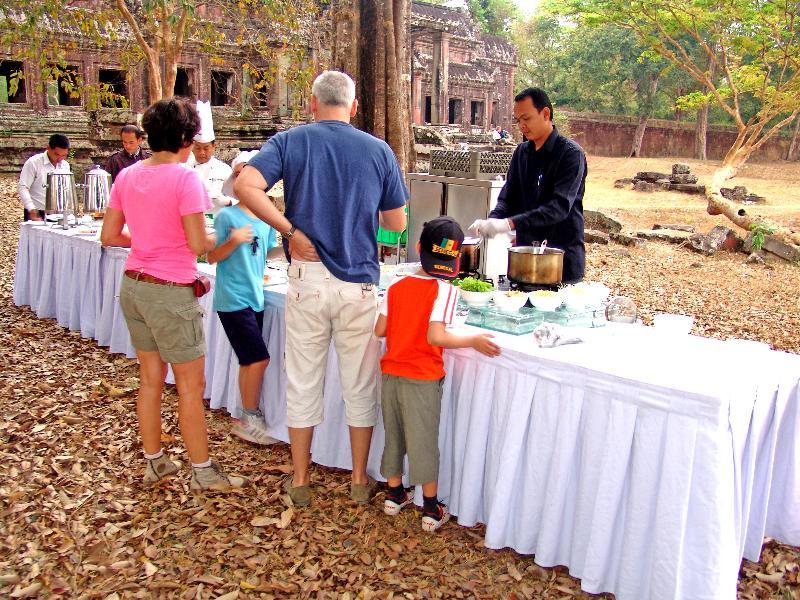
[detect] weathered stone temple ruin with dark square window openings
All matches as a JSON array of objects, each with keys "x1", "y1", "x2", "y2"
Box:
[{"x1": 0, "y1": 1, "x2": 516, "y2": 174}]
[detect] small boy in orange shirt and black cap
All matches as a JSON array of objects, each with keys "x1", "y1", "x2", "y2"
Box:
[{"x1": 375, "y1": 216, "x2": 500, "y2": 531}]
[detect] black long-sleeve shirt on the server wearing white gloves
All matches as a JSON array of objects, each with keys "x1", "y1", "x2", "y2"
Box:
[{"x1": 489, "y1": 128, "x2": 586, "y2": 282}]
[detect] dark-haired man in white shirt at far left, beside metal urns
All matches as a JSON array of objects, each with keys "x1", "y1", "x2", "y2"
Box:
[{"x1": 17, "y1": 133, "x2": 70, "y2": 221}]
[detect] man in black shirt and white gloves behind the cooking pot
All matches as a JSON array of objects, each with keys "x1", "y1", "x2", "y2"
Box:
[{"x1": 469, "y1": 88, "x2": 586, "y2": 283}]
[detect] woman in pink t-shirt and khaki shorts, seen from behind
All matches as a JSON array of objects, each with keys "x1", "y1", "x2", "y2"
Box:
[{"x1": 100, "y1": 98, "x2": 247, "y2": 491}]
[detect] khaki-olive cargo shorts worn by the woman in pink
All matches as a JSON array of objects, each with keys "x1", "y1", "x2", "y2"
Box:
[{"x1": 119, "y1": 275, "x2": 206, "y2": 365}]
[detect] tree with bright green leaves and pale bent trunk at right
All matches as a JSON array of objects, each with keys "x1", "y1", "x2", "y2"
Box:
[{"x1": 565, "y1": 0, "x2": 800, "y2": 247}]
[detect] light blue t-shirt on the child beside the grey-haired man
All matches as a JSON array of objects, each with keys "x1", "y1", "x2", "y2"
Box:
[{"x1": 214, "y1": 206, "x2": 278, "y2": 312}]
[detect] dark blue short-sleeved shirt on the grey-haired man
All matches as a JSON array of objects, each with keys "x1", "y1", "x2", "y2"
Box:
[{"x1": 247, "y1": 121, "x2": 408, "y2": 284}]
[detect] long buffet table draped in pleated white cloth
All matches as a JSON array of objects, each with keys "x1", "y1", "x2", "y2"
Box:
[{"x1": 14, "y1": 224, "x2": 800, "y2": 600}]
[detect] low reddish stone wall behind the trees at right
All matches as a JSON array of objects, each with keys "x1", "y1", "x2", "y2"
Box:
[{"x1": 557, "y1": 111, "x2": 790, "y2": 162}]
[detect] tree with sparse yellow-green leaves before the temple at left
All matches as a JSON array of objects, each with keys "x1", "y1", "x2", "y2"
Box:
[{"x1": 0, "y1": 0, "x2": 318, "y2": 102}]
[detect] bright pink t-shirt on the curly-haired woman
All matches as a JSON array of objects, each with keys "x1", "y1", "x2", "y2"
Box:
[{"x1": 108, "y1": 162, "x2": 211, "y2": 283}]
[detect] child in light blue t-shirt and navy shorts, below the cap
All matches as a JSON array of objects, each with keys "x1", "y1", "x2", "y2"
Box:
[{"x1": 208, "y1": 190, "x2": 281, "y2": 445}]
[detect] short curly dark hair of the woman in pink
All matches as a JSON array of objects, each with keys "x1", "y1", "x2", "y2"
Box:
[{"x1": 142, "y1": 97, "x2": 200, "y2": 152}]
